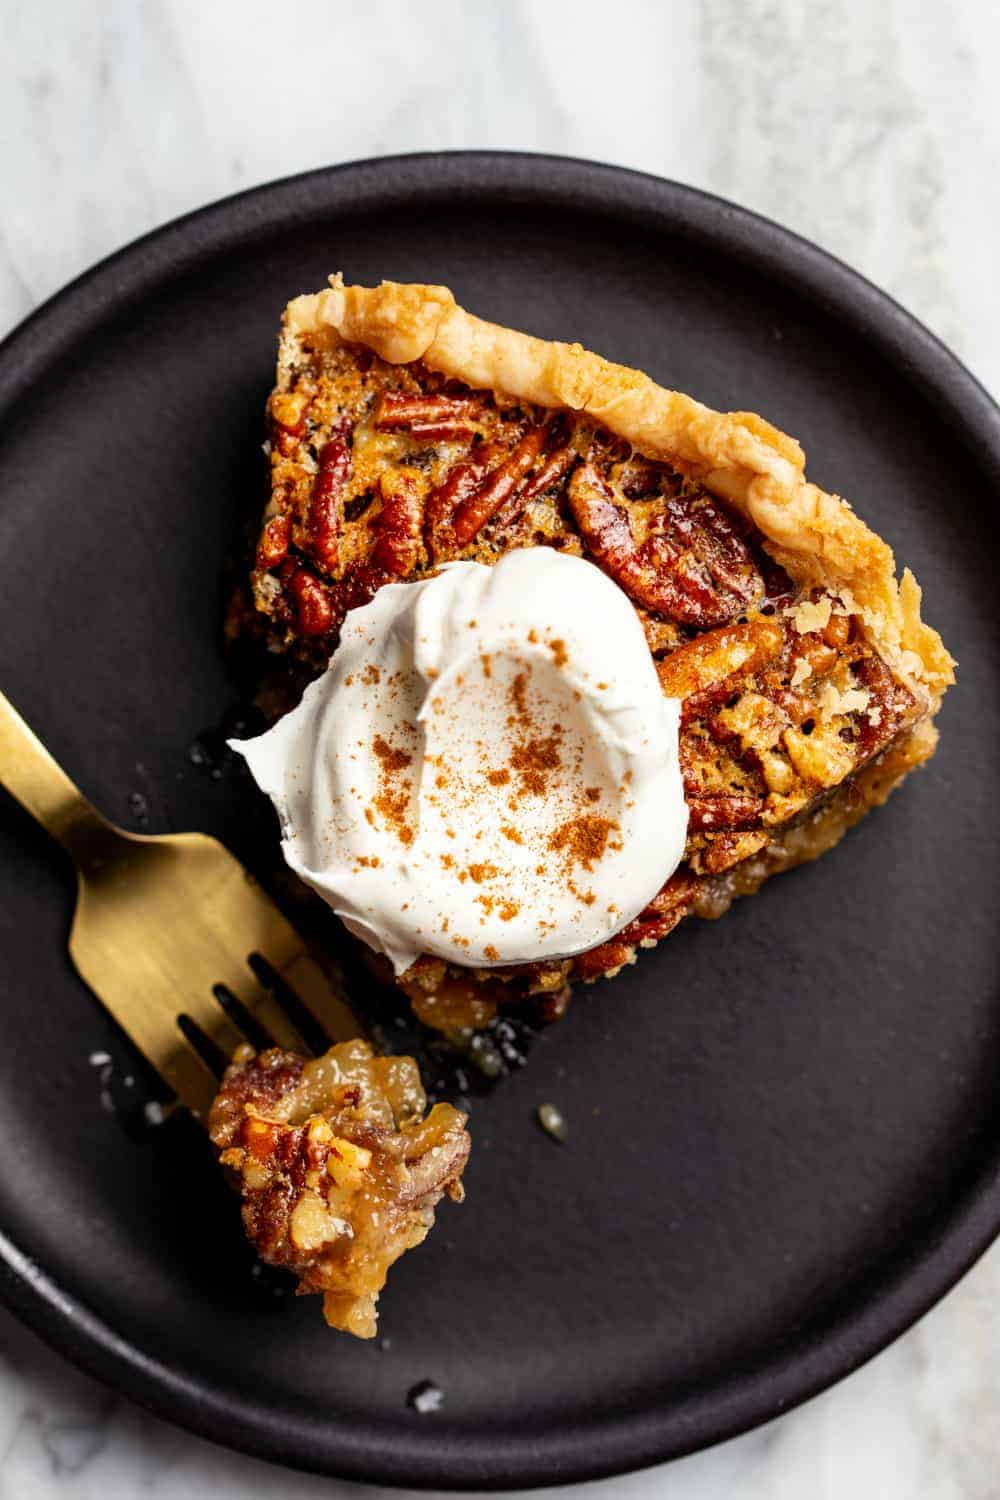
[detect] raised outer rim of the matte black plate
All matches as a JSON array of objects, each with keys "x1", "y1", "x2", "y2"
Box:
[{"x1": 0, "y1": 150, "x2": 1000, "y2": 1490}]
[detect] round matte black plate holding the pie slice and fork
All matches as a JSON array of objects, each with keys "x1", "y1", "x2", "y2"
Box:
[{"x1": 0, "y1": 155, "x2": 1000, "y2": 1488}]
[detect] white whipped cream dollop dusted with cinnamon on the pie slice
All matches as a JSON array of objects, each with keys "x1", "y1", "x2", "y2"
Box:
[{"x1": 232, "y1": 548, "x2": 688, "y2": 974}]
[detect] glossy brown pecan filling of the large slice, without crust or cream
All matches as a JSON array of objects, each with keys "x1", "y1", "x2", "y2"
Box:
[{"x1": 229, "y1": 282, "x2": 951, "y2": 1031}]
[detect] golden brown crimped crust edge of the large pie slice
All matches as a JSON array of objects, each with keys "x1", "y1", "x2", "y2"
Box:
[{"x1": 279, "y1": 278, "x2": 954, "y2": 710}]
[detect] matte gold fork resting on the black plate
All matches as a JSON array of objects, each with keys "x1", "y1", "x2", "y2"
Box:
[{"x1": 0, "y1": 693, "x2": 361, "y2": 1119}]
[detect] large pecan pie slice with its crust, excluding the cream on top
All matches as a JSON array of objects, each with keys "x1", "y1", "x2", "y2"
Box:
[{"x1": 234, "y1": 278, "x2": 954, "y2": 1029}]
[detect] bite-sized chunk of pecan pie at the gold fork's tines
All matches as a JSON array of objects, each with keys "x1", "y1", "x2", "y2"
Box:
[{"x1": 208, "y1": 1041, "x2": 469, "y2": 1338}]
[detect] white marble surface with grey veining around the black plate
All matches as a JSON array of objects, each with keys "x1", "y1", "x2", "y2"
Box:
[{"x1": 0, "y1": 0, "x2": 1000, "y2": 1500}]
